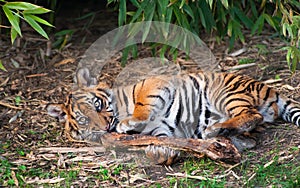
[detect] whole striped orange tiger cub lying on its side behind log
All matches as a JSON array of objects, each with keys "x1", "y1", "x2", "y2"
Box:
[{"x1": 47, "y1": 68, "x2": 300, "y2": 164}]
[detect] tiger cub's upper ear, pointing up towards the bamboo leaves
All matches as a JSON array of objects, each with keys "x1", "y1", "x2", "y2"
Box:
[{"x1": 76, "y1": 68, "x2": 97, "y2": 88}]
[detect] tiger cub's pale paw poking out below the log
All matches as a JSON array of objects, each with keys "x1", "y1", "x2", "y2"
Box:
[{"x1": 145, "y1": 145, "x2": 180, "y2": 166}]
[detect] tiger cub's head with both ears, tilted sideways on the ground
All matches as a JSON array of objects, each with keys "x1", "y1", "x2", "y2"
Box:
[{"x1": 46, "y1": 68, "x2": 117, "y2": 141}]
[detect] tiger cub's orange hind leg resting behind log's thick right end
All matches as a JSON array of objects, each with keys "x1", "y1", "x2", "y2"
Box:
[{"x1": 202, "y1": 109, "x2": 264, "y2": 139}]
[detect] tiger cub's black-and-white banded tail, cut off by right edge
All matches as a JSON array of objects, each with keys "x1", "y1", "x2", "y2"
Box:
[{"x1": 278, "y1": 97, "x2": 300, "y2": 126}]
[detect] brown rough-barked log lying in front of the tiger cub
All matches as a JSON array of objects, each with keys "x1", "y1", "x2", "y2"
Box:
[{"x1": 101, "y1": 133, "x2": 241, "y2": 163}]
